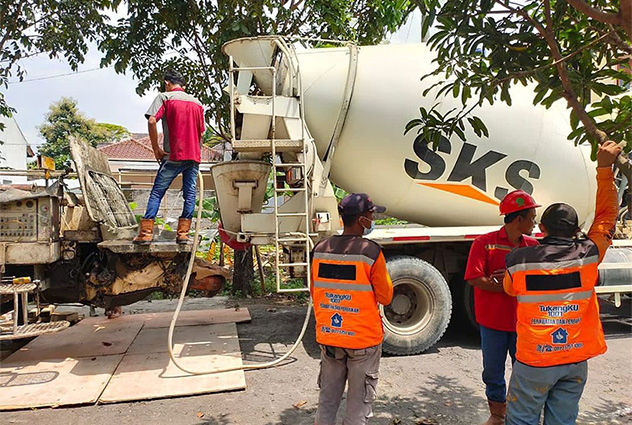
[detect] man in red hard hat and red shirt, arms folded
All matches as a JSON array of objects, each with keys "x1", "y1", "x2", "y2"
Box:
[{"x1": 465, "y1": 190, "x2": 540, "y2": 425}]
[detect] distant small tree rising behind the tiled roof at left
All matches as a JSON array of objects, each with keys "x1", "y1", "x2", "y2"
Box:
[{"x1": 38, "y1": 97, "x2": 129, "y2": 169}]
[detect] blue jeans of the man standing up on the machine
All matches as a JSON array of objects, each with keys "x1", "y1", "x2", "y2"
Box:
[{"x1": 143, "y1": 161, "x2": 200, "y2": 219}]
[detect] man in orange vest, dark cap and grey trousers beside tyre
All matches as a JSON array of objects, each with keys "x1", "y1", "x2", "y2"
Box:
[{"x1": 310, "y1": 193, "x2": 393, "y2": 425}]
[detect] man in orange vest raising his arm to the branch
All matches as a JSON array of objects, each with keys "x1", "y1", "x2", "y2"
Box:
[{"x1": 504, "y1": 142, "x2": 621, "y2": 425}]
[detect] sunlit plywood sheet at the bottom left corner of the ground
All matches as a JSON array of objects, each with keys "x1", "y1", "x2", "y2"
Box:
[{"x1": 0, "y1": 355, "x2": 123, "y2": 410}]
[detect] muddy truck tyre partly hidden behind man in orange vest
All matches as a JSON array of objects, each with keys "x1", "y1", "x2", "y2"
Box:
[{"x1": 380, "y1": 256, "x2": 452, "y2": 355}]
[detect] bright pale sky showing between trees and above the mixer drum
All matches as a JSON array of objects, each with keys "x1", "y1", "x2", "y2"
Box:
[{"x1": 5, "y1": 12, "x2": 421, "y2": 151}]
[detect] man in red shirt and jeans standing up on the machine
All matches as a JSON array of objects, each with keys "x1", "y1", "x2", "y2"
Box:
[{"x1": 134, "y1": 70, "x2": 204, "y2": 245}]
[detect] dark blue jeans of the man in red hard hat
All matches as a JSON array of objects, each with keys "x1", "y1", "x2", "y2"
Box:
[{"x1": 480, "y1": 326, "x2": 516, "y2": 403}]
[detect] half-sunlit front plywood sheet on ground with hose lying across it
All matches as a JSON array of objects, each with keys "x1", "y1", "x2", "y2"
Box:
[{"x1": 99, "y1": 323, "x2": 246, "y2": 403}]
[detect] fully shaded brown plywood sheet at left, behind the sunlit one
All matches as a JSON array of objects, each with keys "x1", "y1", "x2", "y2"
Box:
[{"x1": 6, "y1": 319, "x2": 143, "y2": 363}]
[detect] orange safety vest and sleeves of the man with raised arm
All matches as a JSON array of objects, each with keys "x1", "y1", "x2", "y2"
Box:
[{"x1": 504, "y1": 168, "x2": 618, "y2": 367}]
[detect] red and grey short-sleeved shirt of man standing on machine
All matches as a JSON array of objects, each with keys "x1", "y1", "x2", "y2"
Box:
[{"x1": 145, "y1": 87, "x2": 204, "y2": 162}]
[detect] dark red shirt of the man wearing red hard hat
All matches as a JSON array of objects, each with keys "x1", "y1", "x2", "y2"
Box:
[{"x1": 465, "y1": 226, "x2": 538, "y2": 332}]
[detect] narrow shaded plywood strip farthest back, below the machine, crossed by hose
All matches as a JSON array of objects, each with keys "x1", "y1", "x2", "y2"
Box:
[{"x1": 77, "y1": 308, "x2": 252, "y2": 329}]
